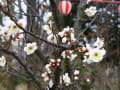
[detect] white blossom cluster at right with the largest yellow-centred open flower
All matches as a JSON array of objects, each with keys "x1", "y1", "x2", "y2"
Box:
[{"x1": 83, "y1": 37, "x2": 106, "y2": 64}]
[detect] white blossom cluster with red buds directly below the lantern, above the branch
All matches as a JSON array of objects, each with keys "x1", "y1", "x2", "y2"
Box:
[{"x1": 58, "y1": 27, "x2": 76, "y2": 44}]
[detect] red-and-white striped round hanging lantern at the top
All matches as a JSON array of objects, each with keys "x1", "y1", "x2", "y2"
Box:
[{"x1": 59, "y1": 0, "x2": 72, "y2": 15}]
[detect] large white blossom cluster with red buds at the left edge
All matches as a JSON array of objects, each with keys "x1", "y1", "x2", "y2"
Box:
[{"x1": 0, "y1": 18, "x2": 26, "y2": 46}]
